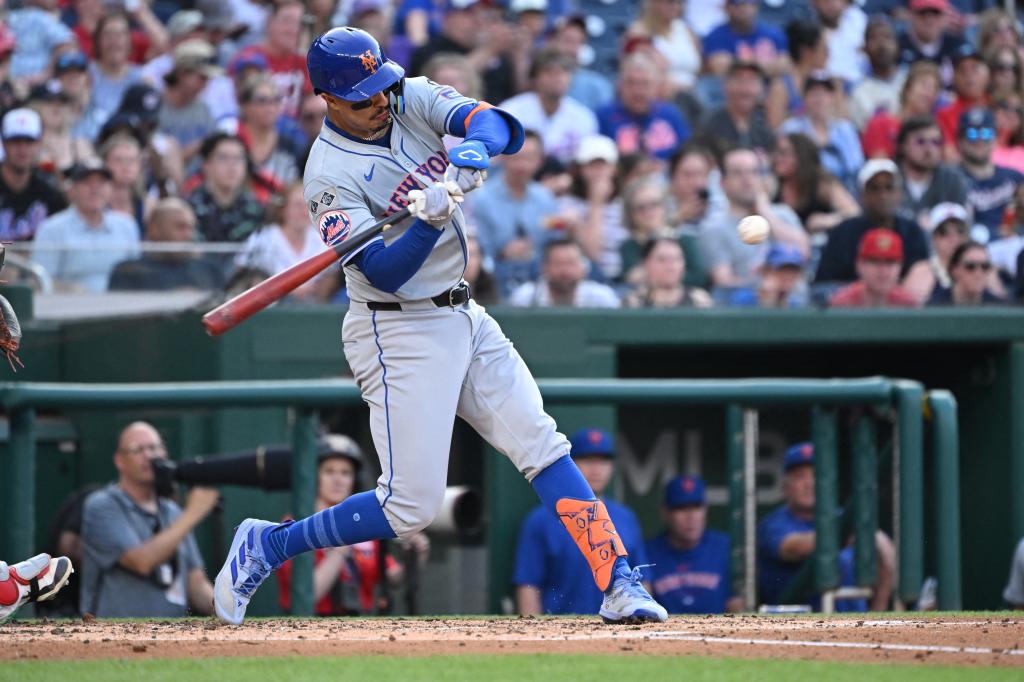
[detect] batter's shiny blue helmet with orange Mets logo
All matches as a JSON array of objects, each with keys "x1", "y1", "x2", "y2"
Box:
[{"x1": 306, "y1": 27, "x2": 406, "y2": 101}]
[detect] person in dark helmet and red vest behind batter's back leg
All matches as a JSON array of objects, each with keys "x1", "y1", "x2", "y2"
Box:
[{"x1": 278, "y1": 434, "x2": 430, "y2": 615}]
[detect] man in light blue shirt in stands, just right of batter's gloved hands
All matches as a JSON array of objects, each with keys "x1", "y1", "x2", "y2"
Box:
[{"x1": 467, "y1": 129, "x2": 558, "y2": 296}]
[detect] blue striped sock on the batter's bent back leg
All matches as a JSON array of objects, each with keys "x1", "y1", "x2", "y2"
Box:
[{"x1": 261, "y1": 491, "x2": 396, "y2": 566}]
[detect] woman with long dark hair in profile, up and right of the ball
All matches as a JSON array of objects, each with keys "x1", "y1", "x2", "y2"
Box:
[{"x1": 771, "y1": 133, "x2": 860, "y2": 237}]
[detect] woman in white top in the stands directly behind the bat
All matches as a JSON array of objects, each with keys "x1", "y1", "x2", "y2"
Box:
[{"x1": 234, "y1": 180, "x2": 338, "y2": 301}]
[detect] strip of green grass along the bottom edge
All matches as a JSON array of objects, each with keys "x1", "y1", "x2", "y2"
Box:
[{"x1": 0, "y1": 654, "x2": 1022, "y2": 682}]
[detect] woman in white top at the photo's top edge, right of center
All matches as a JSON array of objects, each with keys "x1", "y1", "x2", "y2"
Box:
[{"x1": 625, "y1": 0, "x2": 700, "y2": 98}]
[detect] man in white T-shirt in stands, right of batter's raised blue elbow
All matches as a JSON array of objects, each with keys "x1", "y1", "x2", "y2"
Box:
[{"x1": 501, "y1": 48, "x2": 597, "y2": 163}]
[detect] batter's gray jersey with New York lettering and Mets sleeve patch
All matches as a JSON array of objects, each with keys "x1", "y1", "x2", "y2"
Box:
[{"x1": 304, "y1": 78, "x2": 475, "y2": 302}]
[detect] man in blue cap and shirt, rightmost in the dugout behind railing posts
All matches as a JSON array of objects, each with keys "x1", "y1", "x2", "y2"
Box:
[{"x1": 758, "y1": 442, "x2": 895, "y2": 611}]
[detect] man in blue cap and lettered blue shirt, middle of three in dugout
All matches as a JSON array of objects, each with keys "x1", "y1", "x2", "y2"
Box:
[{"x1": 647, "y1": 476, "x2": 743, "y2": 613}]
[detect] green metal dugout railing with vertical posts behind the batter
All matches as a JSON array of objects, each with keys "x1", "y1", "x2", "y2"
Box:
[{"x1": 0, "y1": 378, "x2": 962, "y2": 615}]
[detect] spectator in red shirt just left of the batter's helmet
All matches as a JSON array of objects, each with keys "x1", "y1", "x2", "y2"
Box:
[{"x1": 230, "y1": 0, "x2": 313, "y2": 119}]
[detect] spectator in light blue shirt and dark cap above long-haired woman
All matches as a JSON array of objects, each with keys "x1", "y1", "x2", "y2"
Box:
[{"x1": 779, "y1": 72, "x2": 864, "y2": 191}]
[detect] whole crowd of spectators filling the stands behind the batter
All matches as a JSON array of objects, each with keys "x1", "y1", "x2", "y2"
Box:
[{"x1": 0, "y1": 0, "x2": 1024, "y2": 307}]
